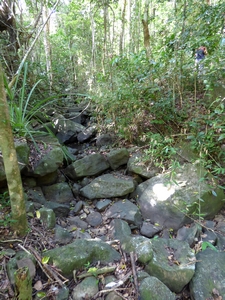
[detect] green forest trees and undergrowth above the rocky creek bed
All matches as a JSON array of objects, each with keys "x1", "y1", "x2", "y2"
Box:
[{"x1": 0, "y1": 0, "x2": 225, "y2": 168}]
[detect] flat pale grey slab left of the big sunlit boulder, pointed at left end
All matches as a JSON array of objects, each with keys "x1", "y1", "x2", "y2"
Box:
[{"x1": 81, "y1": 174, "x2": 134, "y2": 200}]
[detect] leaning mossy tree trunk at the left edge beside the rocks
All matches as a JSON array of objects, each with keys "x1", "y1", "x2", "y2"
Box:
[{"x1": 0, "y1": 64, "x2": 28, "y2": 236}]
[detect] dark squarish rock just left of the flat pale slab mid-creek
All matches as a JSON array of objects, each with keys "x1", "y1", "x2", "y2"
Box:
[{"x1": 42, "y1": 182, "x2": 74, "y2": 204}]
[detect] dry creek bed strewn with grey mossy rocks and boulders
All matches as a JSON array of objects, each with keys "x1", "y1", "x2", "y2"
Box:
[{"x1": 0, "y1": 102, "x2": 225, "y2": 300}]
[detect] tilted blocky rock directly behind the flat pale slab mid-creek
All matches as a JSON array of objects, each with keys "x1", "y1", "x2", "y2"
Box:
[{"x1": 64, "y1": 153, "x2": 109, "y2": 181}]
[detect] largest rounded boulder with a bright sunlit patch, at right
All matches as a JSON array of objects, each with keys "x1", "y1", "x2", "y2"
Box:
[{"x1": 132, "y1": 164, "x2": 224, "y2": 230}]
